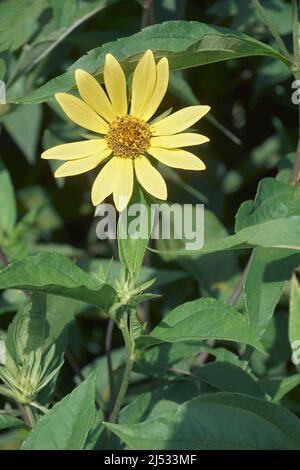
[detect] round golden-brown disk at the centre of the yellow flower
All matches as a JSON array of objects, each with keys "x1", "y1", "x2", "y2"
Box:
[{"x1": 107, "y1": 115, "x2": 151, "y2": 158}]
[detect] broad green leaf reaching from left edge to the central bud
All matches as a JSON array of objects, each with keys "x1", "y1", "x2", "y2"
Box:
[{"x1": 0, "y1": 252, "x2": 115, "y2": 310}]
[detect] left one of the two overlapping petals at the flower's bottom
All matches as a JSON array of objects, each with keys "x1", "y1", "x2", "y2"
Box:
[{"x1": 92, "y1": 157, "x2": 119, "y2": 206}]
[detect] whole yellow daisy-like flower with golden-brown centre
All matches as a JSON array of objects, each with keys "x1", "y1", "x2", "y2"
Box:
[{"x1": 42, "y1": 50, "x2": 210, "y2": 211}]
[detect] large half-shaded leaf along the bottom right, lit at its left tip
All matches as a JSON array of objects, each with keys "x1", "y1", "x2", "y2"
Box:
[{"x1": 105, "y1": 393, "x2": 300, "y2": 450}]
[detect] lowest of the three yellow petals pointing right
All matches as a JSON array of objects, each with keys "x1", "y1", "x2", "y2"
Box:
[{"x1": 147, "y1": 147, "x2": 205, "y2": 170}]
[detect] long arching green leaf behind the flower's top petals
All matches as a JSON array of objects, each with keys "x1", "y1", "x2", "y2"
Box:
[{"x1": 15, "y1": 21, "x2": 287, "y2": 104}]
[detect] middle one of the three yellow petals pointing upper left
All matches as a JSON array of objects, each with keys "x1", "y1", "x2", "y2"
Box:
[{"x1": 75, "y1": 69, "x2": 116, "y2": 122}]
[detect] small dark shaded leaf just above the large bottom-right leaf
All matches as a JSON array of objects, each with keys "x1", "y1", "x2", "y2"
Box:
[{"x1": 196, "y1": 361, "x2": 265, "y2": 398}]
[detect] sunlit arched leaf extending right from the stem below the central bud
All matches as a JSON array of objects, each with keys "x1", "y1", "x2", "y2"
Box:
[{"x1": 138, "y1": 298, "x2": 264, "y2": 352}]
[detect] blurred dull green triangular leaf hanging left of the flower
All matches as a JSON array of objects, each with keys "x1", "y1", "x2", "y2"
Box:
[{"x1": 2, "y1": 105, "x2": 42, "y2": 163}]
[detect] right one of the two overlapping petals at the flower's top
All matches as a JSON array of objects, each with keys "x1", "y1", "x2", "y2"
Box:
[{"x1": 141, "y1": 57, "x2": 169, "y2": 121}]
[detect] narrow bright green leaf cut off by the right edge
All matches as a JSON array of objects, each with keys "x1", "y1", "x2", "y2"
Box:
[{"x1": 289, "y1": 276, "x2": 300, "y2": 372}]
